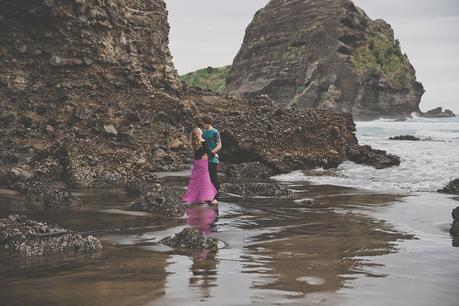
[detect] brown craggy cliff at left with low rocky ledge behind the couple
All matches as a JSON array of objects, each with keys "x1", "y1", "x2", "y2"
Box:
[{"x1": 0, "y1": 0, "x2": 396, "y2": 190}]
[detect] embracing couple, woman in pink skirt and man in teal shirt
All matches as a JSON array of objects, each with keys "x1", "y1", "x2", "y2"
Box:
[{"x1": 183, "y1": 116, "x2": 222, "y2": 204}]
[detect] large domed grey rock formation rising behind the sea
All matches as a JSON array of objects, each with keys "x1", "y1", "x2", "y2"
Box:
[{"x1": 224, "y1": 0, "x2": 424, "y2": 119}]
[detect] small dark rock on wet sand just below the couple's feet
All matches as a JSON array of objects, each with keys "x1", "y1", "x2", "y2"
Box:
[{"x1": 161, "y1": 228, "x2": 218, "y2": 249}]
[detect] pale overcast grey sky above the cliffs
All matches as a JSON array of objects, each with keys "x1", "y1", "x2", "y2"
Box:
[{"x1": 165, "y1": 0, "x2": 459, "y2": 113}]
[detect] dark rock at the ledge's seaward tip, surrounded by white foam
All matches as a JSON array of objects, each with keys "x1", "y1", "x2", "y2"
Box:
[{"x1": 347, "y1": 146, "x2": 400, "y2": 169}]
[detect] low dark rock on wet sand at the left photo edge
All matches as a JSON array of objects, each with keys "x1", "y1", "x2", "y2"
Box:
[{"x1": 0, "y1": 215, "x2": 102, "y2": 257}]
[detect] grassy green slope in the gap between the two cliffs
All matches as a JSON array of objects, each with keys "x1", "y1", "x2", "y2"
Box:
[{"x1": 180, "y1": 66, "x2": 231, "y2": 93}]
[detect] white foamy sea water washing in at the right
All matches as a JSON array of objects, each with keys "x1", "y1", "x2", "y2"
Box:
[{"x1": 274, "y1": 118, "x2": 459, "y2": 192}]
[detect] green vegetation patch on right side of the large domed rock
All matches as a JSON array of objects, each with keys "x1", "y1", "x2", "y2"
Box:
[{"x1": 352, "y1": 33, "x2": 413, "y2": 88}]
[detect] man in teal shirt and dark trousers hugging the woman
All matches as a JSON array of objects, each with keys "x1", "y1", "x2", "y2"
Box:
[{"x1": 202, "y1": 116, "x2": 222, "y2": 203}]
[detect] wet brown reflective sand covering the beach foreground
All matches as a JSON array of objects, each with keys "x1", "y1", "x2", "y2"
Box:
[{"x1": 0, "y1": 175, "x2": 459, "y2": 306}]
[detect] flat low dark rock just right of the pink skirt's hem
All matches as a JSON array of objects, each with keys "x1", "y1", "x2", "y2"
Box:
[{"x1": 221, "y1": 183, "x2": 290, "y2": 197}]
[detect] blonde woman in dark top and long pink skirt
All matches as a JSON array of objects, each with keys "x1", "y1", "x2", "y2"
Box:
[{"x1": 183, "y1": 128, "x2": 217, "y2": 204}]
